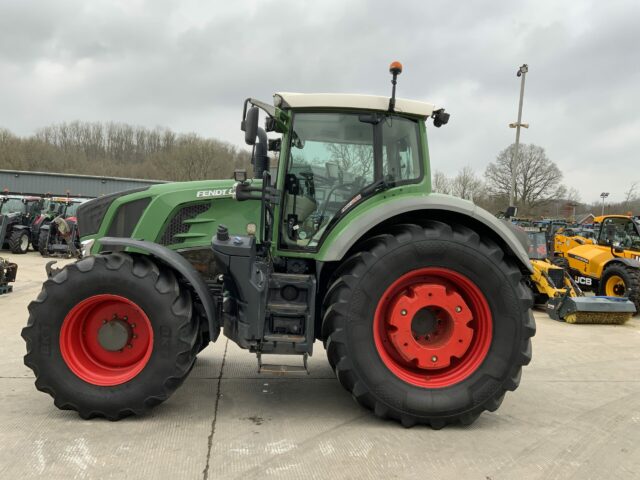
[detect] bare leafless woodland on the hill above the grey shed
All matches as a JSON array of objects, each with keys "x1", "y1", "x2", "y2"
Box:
[{"x1": 0, "y1": 122, "x2": 250, "y2": 180}]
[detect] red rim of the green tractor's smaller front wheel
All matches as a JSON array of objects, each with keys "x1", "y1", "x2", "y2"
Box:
[{"x1": 60, "y1": 294, "x2": 153, "y2": 386}]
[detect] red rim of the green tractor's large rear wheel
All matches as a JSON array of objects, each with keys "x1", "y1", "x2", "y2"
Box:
[{"x1": 373, "y1": 267, "x2": 493, "y2": 388}]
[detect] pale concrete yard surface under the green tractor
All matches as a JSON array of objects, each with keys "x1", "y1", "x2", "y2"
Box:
[{"x1": 0, "y1": 251, "x2": 640, "y2": 480}]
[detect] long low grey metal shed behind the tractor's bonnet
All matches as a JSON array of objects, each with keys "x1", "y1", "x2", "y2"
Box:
[{"x1": 0, "y1": 170, "x2": 167, "y2": 198}]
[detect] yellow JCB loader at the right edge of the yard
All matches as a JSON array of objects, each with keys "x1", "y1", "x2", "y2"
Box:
[{"x1": 553, "y1": 215, "x2": 640, "y2": 311}]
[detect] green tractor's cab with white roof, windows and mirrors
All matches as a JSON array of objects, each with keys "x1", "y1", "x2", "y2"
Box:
[{"x1": 235, "y1": 87, "x2": 449, "y2": 252}]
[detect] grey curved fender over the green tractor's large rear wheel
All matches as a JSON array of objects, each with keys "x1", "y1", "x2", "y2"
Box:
[{"x1": 318, "y1": 193, "x2": 533, "y2": 273}]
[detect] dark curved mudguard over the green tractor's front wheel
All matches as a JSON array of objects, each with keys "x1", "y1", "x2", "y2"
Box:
[{"x1": 100, "y1": 237, "x2": 220, "y2": 341}]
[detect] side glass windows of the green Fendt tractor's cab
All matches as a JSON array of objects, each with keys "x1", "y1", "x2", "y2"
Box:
[{"x1": 281, "y1": 113, "x2": 422, "y2": 249}]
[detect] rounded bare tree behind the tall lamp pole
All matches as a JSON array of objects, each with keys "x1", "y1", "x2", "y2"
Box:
[{"x1": 485, "y1": 144, "x2": 566, "y2": 208}]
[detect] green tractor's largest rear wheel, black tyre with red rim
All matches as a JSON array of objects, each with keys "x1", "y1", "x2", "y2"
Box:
[{"x1": 323, "y1": 221, "x2": 535, "y2": 428}]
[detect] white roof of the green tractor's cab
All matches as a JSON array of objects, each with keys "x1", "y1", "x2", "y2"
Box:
[{"x1": 273, "y1": 92, "x2": 436, "y2": 117}]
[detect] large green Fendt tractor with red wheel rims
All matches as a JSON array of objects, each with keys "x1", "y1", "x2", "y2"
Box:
[{"x1": 22, "y1": 62, "x2": 535, "y2": 428}]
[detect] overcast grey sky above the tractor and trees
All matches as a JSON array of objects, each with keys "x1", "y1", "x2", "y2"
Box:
[{"x1": 0, "y1": 0, "x2": 640, "y2": 202}]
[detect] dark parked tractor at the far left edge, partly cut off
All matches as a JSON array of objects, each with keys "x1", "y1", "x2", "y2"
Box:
[{"x1": 0, "y1": 195, "x2": 42, "y2": 253}]
